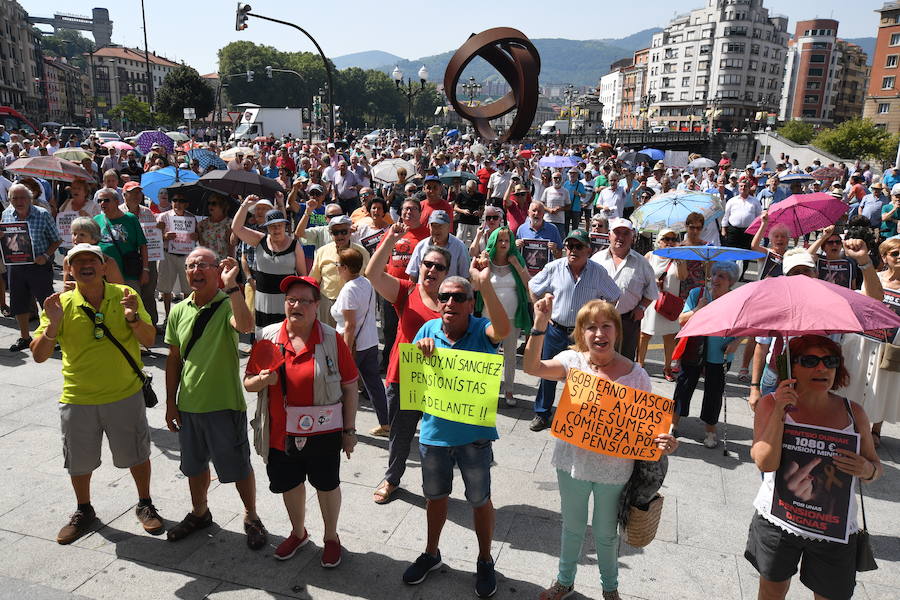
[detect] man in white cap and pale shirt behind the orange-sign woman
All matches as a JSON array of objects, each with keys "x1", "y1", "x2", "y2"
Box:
[{"x1": 591, "y1": 218, "x2": 659, "y2": 360}]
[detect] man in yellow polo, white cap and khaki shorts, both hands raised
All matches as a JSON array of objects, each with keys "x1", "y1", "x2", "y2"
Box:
[{"x1": 31, "y1": 244, "x2": 164, "y2": 544}]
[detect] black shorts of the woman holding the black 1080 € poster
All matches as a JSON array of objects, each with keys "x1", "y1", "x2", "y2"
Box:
[{"x1": 744, "y1": 513, "x2": 859, "y2": 600}]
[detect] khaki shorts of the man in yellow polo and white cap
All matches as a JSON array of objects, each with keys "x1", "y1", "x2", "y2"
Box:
[{"x1": 59, "y1": 390, "x2": 150, "y2": 476}]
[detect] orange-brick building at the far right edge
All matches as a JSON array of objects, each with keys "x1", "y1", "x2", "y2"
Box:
[{"x1": 863, "y1": 2, "x2": 900, "y2": 133}]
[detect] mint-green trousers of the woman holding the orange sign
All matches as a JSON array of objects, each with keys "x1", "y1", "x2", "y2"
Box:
[{"x1": 556, "y1": 469, "x2": 625, "y2": 592}]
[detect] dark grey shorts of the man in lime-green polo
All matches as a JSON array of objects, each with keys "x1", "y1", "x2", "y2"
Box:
[{"x1": 178, "y1": 410, "x2": 253, "y2": 483}]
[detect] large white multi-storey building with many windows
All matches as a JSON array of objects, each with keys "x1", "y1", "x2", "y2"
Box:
[{"x1": 647, "y1": 0, "x2": 788, "y2": 131}]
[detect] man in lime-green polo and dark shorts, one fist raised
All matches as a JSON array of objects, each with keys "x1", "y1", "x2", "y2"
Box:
[{"x1": 166, "y1": 247, "x2": 268, "y2": 550}]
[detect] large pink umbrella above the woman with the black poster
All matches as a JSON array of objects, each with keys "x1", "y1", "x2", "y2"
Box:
[{"x1": 678, "y1": 275, "x2": 900, "y2": 337}]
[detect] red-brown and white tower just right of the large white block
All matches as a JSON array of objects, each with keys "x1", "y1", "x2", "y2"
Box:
[{"x1": 778, "y1": 19, "x2": 843, "y2": 126}]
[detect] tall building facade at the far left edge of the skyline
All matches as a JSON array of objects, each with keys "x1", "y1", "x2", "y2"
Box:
[{"x1": 0, "y1": 0, "x2": 44, "y2": 120}]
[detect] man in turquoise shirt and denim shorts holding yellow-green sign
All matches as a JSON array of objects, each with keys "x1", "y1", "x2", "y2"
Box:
[{"x1": 400, "y1": 268, "x2": 510, "y2": 598}]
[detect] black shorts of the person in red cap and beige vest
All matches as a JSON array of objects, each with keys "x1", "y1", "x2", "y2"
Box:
[{"x1": 266, "y1": 431, "x2": 343, "y2": 494}]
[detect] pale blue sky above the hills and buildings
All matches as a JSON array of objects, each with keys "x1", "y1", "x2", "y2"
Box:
[{"x1": 18, "y1": 0, "x2": 881, "y2": 73}]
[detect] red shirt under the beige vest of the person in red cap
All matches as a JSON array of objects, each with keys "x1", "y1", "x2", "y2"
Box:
[{"x1": 246, "y1": 321, "x2": 359, "y2": 451}]
